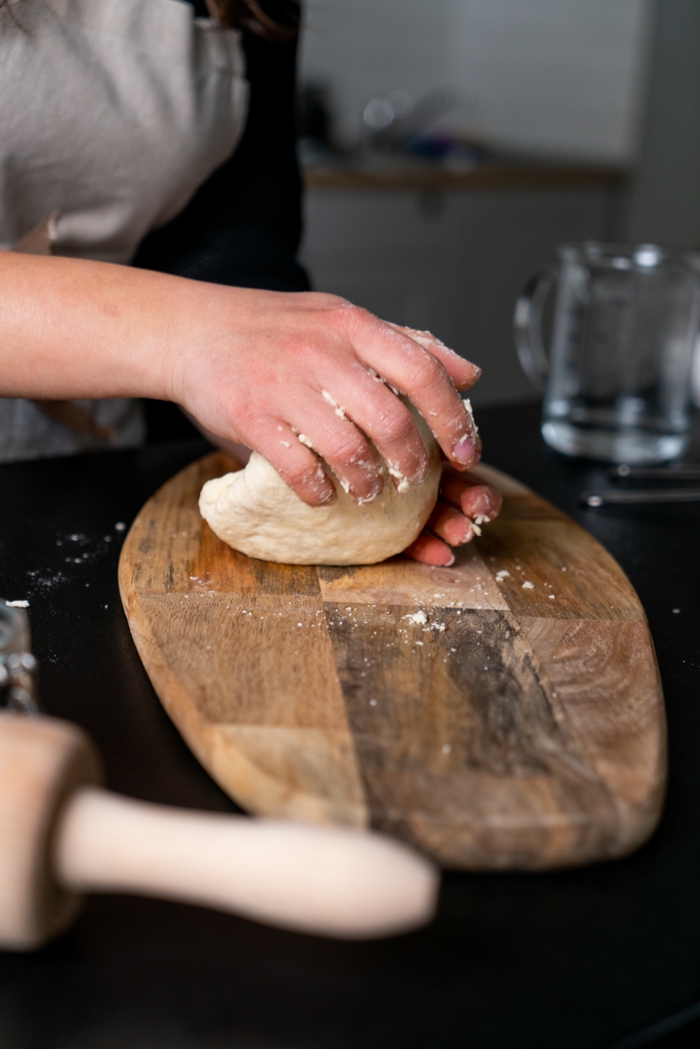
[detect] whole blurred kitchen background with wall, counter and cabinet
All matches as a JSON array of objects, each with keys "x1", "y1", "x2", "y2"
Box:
[{"x1": 299, "y1": 0, "x2": 700, "y2": 405}]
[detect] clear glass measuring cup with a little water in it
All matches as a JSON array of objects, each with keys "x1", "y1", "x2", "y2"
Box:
[{"x1": 514, "y1": 241, "x2": 700, "y2": 465}]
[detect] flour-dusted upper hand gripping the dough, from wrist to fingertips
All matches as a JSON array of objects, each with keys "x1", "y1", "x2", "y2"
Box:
[{"x1": 168, "y1": 285, "x2": 481, "y2": 506}]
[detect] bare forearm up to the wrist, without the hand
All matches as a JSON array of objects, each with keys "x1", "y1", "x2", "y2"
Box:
[{"x1": 0, "y1": 252, "x2": 188, "y2": 399}]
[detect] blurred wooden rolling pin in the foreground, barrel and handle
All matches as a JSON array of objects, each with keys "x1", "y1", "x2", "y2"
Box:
[{"x1": 0, "y1": 711, "x2": 438, "y2": 949}]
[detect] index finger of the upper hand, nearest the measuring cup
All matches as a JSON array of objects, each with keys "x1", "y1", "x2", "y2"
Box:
[{"x1": 351, "y1": 312, "x2": 479, "y2": 467}]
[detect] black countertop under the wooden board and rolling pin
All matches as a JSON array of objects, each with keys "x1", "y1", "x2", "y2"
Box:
[{"x1": 0, "y1": 405, "x2": 700, "y2": 1049}]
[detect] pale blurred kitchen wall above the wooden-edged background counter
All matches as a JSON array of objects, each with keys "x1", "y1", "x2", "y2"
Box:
[{"x1": 301, "y1": 0, "x2": 651, "y2": 164}]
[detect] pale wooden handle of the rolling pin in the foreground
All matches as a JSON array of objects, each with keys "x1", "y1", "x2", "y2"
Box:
[{"x1": 54, "y1": 788, "x2": 438, "y2": 939}]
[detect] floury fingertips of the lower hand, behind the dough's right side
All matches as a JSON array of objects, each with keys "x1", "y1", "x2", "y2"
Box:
[{"x1": 405, "y1": 464, "x2": 503, "y2": 566}]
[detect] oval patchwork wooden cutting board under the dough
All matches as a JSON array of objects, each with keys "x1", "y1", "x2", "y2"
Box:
[{"x1": 120, "y1": 454, "x2": 666, "y2": 871}]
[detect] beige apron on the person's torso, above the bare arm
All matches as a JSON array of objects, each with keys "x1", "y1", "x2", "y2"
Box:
[{"x1": 0, "y1": 0, "x2": 247, "y2": 262}]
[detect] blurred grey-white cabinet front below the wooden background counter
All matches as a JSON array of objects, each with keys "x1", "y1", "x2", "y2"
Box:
[{"x1": 302, "y1": 188, "x2": 608, "y2": 405}]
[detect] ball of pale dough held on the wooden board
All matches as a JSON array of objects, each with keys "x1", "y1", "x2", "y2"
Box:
[{"x1": 199, "y1": 413, "x2": 441, "y2": 564}]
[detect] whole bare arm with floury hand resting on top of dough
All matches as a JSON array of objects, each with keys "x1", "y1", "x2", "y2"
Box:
[{"x1": 0, "y1": 254, "x2": 479, "y2": 504}]
